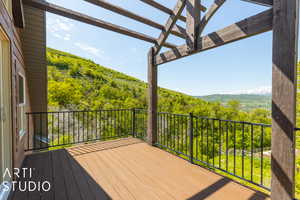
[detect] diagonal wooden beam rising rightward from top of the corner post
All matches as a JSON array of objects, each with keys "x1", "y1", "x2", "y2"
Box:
[{"x1": 154, "y1": 0, "x2": 186, "y2": 55}]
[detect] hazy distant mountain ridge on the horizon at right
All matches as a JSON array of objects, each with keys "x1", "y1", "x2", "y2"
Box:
[{"x1": 198, "y1": 93, "x2": 271, "y2": 111}]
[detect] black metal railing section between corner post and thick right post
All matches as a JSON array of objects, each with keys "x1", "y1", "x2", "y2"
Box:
[{"x1": 157, "y1": 113, "x2": 271, "y2": 190}]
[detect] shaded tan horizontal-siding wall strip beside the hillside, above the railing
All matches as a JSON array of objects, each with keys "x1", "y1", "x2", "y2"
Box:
[{"x1": 21, "y1": 5, "x2": 47, "y2": 112}]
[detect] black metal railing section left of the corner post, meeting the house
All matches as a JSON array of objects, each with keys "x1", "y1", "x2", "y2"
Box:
[{"x1": 26, "y1": 109, "x2": 146, "y2": 151}]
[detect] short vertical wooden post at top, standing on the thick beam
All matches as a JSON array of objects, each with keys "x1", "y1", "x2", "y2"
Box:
[{"x1": 186, "y1": 0, "x2": 201, "y2": 51}]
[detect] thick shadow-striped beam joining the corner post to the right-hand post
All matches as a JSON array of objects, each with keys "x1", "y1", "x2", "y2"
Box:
[{"x1": 154, "y1": 9, "x2": 273, "y2": 65}]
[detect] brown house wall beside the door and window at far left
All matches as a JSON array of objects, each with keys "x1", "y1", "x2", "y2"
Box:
[{"x1": 0, "y1": 0, "x2": 30, "y2": 171}]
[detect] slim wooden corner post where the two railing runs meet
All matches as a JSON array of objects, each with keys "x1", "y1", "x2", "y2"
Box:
[{"x1": 147, "y1": 48, "x2": 157, "y2": 145}]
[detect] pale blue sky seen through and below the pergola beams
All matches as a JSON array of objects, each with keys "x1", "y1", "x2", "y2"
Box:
[{"x1": 47, "y1": 0, "x2": 298, "y2": 95}]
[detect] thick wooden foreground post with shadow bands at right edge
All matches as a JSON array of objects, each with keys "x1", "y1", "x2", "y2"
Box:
[{"x1": 271, "y1": 0, "x2": 298, "y2": 200}]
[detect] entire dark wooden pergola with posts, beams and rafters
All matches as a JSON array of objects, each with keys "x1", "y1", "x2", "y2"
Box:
[{"x1": 23, "y1": 0, "x2": 298, "y2": 200}]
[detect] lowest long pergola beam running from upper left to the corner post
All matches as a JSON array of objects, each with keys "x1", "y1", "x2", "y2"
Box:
[{"x1": 23, "y1": 0, "x2": 176, "y2": 48}]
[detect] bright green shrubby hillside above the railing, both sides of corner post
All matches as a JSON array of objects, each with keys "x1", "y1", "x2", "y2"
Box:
[{"x1": 47, "y1": 48, "x2": 270, "y2": 123}]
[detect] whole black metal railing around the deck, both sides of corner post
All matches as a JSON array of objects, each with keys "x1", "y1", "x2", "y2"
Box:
[{"x1": 25, "y1": 109, "x2": 299, "y2": 193}]
